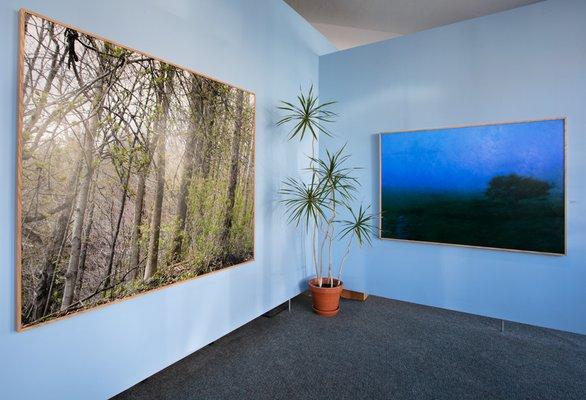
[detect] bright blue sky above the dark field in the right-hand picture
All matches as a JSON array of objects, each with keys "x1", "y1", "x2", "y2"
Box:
[{"x1": 381, "y1": 120, "x2": 564, "y2": 192}]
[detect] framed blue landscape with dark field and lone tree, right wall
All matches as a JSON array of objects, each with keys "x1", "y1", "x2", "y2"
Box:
[{"x1": 380, "y1": 119, "x2": 566, "y2": 255}]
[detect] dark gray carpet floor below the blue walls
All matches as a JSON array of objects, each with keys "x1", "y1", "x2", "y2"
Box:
[{"x1": 114, "y1": 295, "x2": 586, "y2": 400}]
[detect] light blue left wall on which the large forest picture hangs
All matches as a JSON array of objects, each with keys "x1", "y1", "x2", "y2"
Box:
[{"x1": 0, "y1": 0, "x2": 334, "y2": 399}]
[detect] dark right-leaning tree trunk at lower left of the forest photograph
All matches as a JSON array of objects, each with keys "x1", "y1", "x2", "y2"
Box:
[{"x1": 31, "y1": 159, "x2": 81, "y2": 320}]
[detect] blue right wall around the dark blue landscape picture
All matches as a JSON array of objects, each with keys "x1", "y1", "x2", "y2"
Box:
[{"x1": 320, "y1": 0, "x2": 586, "y2": 333}]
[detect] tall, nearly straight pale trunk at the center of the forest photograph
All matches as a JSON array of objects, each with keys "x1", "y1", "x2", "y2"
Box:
[{"x1": 144, "y1": 67, "x2": 174, "y2": 279}]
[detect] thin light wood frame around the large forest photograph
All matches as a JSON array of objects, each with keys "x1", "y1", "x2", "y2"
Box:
[{"x1": 15, "y1": 8, "x2": 257, "y2": 332}]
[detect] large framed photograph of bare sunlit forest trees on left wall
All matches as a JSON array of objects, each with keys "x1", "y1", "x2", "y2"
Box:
[{"x1": 16, "y1": 10, "x2": 255, "y2": 330}]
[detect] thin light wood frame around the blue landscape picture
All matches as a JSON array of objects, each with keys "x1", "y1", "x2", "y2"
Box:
[{"x1": 378, "y1": 117, "x2": 568, "y2": 257}]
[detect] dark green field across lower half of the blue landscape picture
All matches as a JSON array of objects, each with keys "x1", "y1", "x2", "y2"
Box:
[{"x1": 383, "y1": 193, "x2": 564, "y2": 253}]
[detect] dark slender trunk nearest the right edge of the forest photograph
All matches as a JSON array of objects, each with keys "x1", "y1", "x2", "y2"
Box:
[{"x1": 220, "y1": 90, "x2": 244, "y2": 246}]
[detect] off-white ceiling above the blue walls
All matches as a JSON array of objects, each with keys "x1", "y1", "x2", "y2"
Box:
[{"x1": 285, "y1": 0, "x2": 541, "y2": 50}]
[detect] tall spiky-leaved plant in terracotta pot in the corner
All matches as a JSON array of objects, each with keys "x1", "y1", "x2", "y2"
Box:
[{"x1": 277, "y1": 87, "x2": 374, "y2": 316}]
